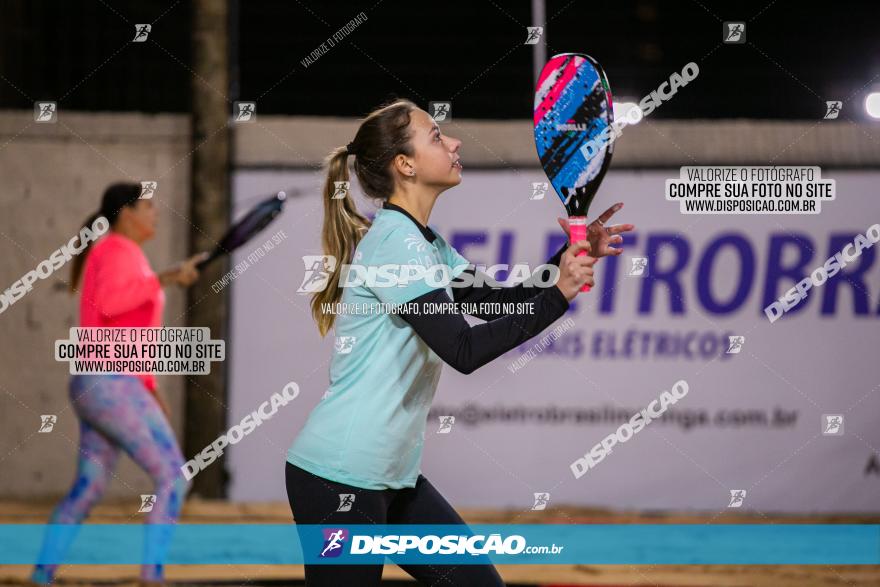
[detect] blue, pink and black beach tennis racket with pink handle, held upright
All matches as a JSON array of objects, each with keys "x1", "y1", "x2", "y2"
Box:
[{"x1": 534, "y1": 53, "x2": 614, "y2": 291}]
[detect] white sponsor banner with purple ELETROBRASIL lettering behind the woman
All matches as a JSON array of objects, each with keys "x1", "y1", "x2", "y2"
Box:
[{"x1": 228, "y1": 169, "x2": 880, "y2": 512}]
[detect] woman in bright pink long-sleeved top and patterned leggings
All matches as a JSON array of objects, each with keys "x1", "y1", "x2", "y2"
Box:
[{"x1": 32, "y1": 183, "x2": 203, "y2": 584}]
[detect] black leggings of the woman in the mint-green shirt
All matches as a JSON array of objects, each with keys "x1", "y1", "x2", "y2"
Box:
[{"x1": 285, "y1": 463, "x2": 504, "y2": 587}]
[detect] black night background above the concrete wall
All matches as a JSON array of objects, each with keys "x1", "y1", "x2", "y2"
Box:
[{"x1": 0, "y1": 0, "x2": 880, "y2": 120}]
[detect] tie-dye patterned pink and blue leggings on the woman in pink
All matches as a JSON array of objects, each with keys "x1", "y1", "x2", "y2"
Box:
[{"x1": 31, "y1": 375, "x2": 189, "y2": 584}]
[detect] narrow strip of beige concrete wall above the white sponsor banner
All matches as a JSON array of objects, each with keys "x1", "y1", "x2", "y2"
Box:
[{"x1": 235, "y1": 116, "x2": 880, "y2": 169}]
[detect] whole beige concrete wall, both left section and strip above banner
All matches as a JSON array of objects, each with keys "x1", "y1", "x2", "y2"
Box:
[{"x1": 0, "y1": 111, "x2": 880, "y2": 499}]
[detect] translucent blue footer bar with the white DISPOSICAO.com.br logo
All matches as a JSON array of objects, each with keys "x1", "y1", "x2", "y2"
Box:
[{"x1": 0, "y1": 524, "x2": 880, "y2": 565}]
